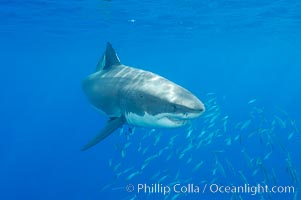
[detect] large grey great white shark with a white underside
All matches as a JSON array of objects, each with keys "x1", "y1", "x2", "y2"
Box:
[{"x1": 82, "y1": 43, "x2": 205, "y2": 150}]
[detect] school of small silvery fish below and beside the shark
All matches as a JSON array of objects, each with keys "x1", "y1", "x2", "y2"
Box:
[{"x1": 101, "y1": 93, "x2": 300, "y2": 200}]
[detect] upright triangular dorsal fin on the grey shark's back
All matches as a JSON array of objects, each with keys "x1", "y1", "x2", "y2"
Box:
[{"x1": 96, "y1": 42, "x2": 121, "y2": 71}]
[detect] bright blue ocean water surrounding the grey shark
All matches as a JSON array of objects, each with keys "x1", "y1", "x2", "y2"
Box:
[{"x1": 0, "y1": 0, "x2": 301, "y2": 200}]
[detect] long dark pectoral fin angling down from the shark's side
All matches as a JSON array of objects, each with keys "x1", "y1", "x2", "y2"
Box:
[{"x1": 82, "y1": 117, "x2": 124, "y2": 151}]
